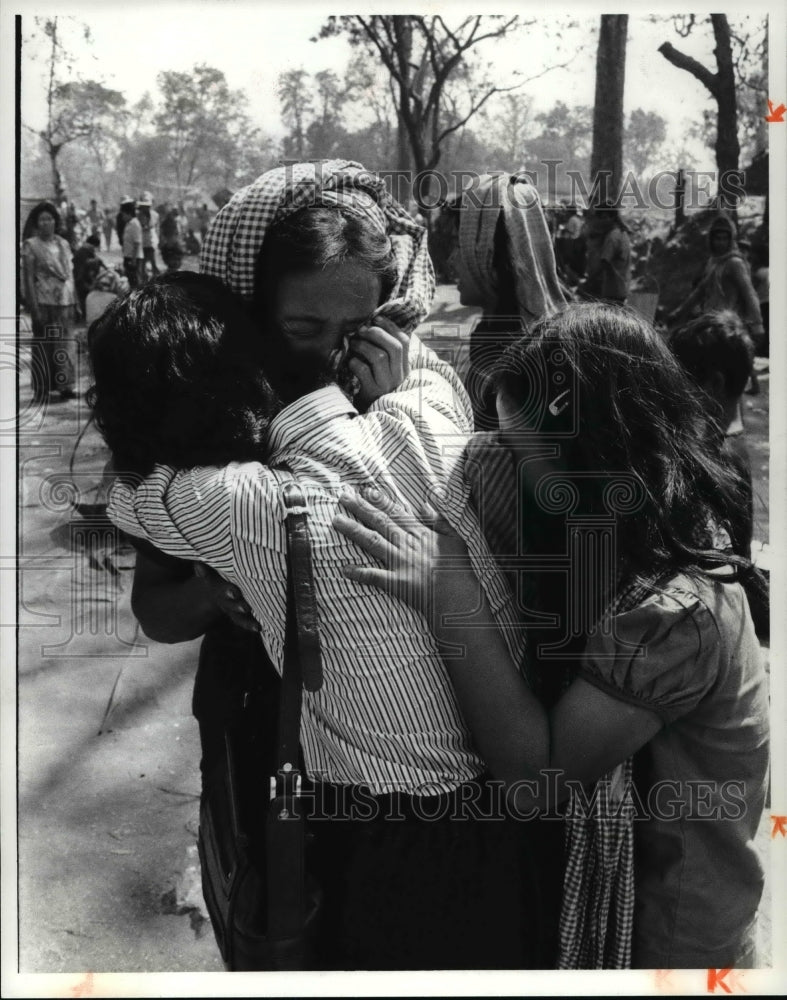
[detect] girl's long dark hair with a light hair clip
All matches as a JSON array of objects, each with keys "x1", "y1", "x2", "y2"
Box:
[{"x1": 496, "y1": 303, "x2": 748, "y2": 580}]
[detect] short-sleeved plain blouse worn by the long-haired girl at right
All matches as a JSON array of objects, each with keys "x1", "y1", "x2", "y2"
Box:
[{"x1": 580, "y1": 576, "x2": 768, "y2": 968}]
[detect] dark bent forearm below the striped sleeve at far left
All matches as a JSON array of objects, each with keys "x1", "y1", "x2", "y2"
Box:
[{"x1": 131, "y1": 576, "x2": 223, "y2": 643}]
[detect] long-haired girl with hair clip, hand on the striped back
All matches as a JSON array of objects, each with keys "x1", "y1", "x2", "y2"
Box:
[{"x1": 335, "y1": 305, "x2": 768, "y2": 968}]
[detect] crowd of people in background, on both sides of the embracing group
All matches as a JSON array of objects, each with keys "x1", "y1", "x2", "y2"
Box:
[{"x1": 21, "y1": 181, "x2": 769, "y2": 438}]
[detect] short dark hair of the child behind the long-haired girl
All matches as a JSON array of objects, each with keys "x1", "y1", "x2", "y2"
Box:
[{"x1": 669, "y1": 309, "x2": 754, "y2": 397}]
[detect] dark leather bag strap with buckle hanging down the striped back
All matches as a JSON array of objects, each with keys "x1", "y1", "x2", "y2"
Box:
[{"x1": 266, "y1": 483, "x2": 322, "y2": 940}]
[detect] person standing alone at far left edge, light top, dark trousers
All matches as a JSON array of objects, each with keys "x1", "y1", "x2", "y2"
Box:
[{"x1": 22, "y1": 201, "x2": 76, "y2": 402}]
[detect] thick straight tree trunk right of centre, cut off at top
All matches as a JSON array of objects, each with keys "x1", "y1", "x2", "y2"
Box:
[{"x1": 590, "y1": 14, "x2": 628, "y2": 203}]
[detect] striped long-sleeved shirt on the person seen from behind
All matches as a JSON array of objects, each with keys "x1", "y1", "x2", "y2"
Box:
[{"x1": 109, "y1": 338, "x2": 522, "y2": 795}]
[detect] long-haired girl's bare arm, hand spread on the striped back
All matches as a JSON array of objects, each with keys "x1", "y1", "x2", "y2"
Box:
[{"x1": 334, "y1": 498, "x2": 662, "y2": 805}]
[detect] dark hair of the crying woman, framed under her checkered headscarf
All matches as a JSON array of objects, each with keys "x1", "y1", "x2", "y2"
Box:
[{"x1": 254, "y1": 205, "x2": 397, "y2": 323}]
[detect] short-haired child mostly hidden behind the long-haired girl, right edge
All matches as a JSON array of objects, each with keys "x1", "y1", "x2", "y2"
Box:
[{"x1": 669, "y1": 309, "x2": 768, "y2": 638}]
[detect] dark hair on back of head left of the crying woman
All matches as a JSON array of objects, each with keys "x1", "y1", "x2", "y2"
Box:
[{"x1": 88, "y1": 271, "x2": 278, "y2": 475}]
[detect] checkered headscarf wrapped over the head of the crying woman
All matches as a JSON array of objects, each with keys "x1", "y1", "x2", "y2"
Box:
[{"x1": 200, "y1": 160, "x2": 435, "y2": 333}]
